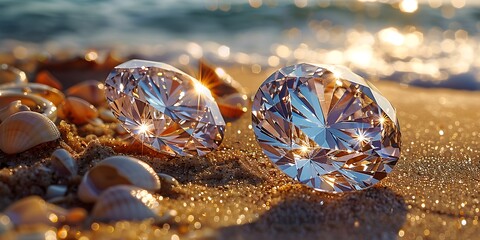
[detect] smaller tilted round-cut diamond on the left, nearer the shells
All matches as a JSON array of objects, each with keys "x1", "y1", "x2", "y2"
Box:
[{"x1": 105, "y1": 60, "x2": 225, "y2": 156}]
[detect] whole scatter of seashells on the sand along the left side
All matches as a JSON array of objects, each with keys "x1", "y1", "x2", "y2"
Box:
[{"x1": 0, "y1": 62, "x2": 179, "y2": 239}]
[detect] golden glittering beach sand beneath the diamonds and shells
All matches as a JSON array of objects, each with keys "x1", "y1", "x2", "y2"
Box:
[{"x1": 0, "y1": 69, "x2": 480, "y2": 239}]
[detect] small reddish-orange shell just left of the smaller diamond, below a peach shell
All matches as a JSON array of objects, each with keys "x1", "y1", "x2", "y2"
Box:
[{"x1": 58, "y1": 97, "x2": 98, "y2": 124}]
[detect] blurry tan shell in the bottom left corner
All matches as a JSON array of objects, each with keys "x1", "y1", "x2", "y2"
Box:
[{"x1": 4, "y1": 196, "x2": 68, "y2": 226}]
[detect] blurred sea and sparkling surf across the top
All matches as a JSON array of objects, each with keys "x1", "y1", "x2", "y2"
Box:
[{"x1": 0, "y1": 0, "x2": 480, "y2": 90}]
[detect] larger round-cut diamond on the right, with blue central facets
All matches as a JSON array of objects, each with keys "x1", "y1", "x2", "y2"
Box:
[{"x1": 252, "y1": 63, "x2": 401, "y2": 192}]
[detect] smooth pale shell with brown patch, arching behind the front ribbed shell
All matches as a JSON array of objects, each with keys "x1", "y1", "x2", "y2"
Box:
[{"x1": 78, "y1": 156, "x2": 160, "y2": 202}]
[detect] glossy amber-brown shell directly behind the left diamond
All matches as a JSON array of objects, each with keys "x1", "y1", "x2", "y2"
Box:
[{"x1": 198, "y1": 60, "x2": 248, "y2": 121}]
